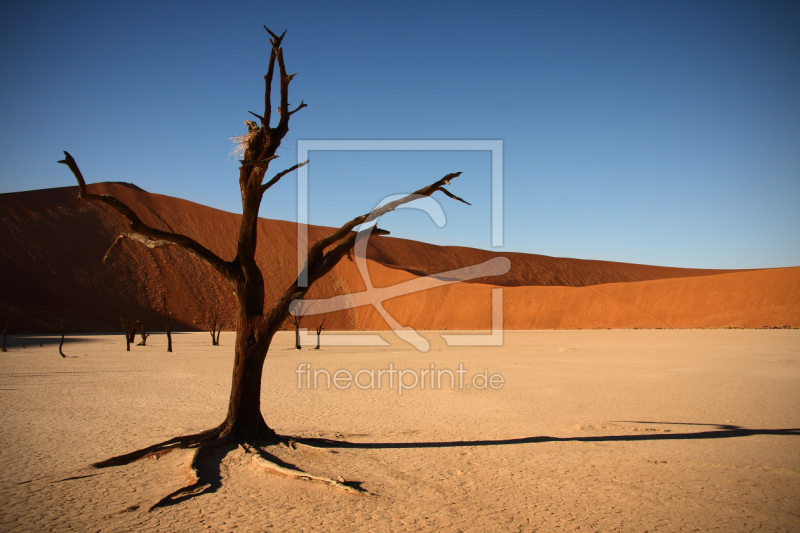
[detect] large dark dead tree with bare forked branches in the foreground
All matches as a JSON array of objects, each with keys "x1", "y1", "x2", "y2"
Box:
[{"x1": 59, "y1": 30, "x2": 467, "y2": 508}]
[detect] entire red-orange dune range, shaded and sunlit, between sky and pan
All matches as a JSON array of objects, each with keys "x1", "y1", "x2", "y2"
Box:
[{"x1": 0, "y1": 183, "x2": 800, "y2": 333}]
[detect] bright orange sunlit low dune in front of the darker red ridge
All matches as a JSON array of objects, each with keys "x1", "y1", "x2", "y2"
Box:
[{"x1": 370, "y1": 265, "x2": 800, "y2": 329}]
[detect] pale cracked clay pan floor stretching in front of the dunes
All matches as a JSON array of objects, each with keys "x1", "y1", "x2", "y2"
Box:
[{"x1": 0, "y1": 330, "x2": 800, "y2": 531}]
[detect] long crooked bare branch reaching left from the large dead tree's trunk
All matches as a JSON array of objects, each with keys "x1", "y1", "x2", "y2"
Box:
[{"x1": 59, "y1": 152, "x2": 236, "y2": 281}]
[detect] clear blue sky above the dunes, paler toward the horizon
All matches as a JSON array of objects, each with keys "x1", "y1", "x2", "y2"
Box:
[{"x1": 0, "y1": 1, "x2": 800, "y2": 268}]
